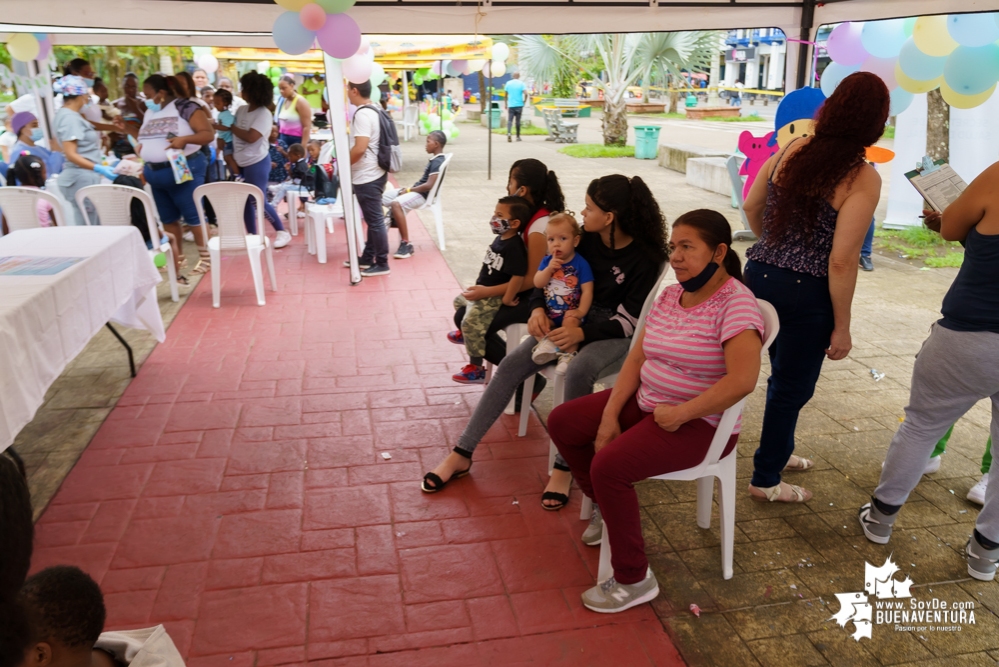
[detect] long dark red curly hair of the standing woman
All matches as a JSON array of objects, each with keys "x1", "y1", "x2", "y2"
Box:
[{"x1": 767, "y1": 72, "x2": 889, "y2": 240}]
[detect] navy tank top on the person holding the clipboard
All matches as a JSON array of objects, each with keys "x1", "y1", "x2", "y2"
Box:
[{"x1": 940, "y1": 228, "x2": 999, "y2": 334}]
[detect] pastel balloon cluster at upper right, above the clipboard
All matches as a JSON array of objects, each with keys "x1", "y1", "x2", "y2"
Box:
[{"x1": 821, "y1": 14, "x2": 999, "y2": 115}]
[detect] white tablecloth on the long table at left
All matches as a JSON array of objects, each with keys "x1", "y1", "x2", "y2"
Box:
[{"x1": 0, "y1": 227, "x2": 166, "y2": 451}]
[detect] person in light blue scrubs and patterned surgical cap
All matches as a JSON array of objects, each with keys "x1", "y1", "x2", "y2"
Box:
[{"x1": 52, "y1": 75, "x2": 117, "y2": 225}]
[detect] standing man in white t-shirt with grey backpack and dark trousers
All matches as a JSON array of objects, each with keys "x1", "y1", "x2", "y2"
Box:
[{"x1": 344, "y1": 81, "x2": 391, "y2": 278}]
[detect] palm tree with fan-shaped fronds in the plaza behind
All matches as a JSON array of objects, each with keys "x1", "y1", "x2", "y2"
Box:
[{"x1": 517, "y1": 31, "x2": 719, "y2": 146}]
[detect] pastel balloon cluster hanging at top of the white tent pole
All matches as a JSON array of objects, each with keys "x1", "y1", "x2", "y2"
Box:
[{"x1": 271, "y1": 0, "x2": 364, "y2": 59}]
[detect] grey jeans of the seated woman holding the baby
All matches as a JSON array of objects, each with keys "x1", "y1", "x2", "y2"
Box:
[{"x1": 458, "y1": 336, "x2": 631, "y2": 466}]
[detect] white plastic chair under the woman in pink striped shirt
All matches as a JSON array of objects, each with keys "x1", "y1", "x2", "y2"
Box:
[{"x1": 597, "y1": 299, "x2": 780, "y2": 581}]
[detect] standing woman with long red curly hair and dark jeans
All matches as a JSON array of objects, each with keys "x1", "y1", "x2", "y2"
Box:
[{"x1": 743, "y1": 72, "x2": 888, "y2": 503}]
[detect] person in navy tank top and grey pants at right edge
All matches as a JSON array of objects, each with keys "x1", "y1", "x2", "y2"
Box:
[{"x1": 859, "y1": 163, "x2": 999, "y2": 581}]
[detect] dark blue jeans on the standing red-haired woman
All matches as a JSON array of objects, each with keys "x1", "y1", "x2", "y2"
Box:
[{"x1": 746, "y1": 260, "x2": 835, "y2": 488}]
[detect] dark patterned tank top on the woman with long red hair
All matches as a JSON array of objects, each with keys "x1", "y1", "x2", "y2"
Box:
[{"x1": 746, "y1": 142, "x2": 839, "y2": 278}]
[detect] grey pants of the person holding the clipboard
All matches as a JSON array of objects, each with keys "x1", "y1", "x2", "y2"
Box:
[{"x1": 874, "y1": 323, "x2": 999, "y2": 541}]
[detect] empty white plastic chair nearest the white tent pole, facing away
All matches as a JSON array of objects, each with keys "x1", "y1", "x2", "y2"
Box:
[{"x1": 194, "y1": 182, "x2": 277, "y2": 308}]
